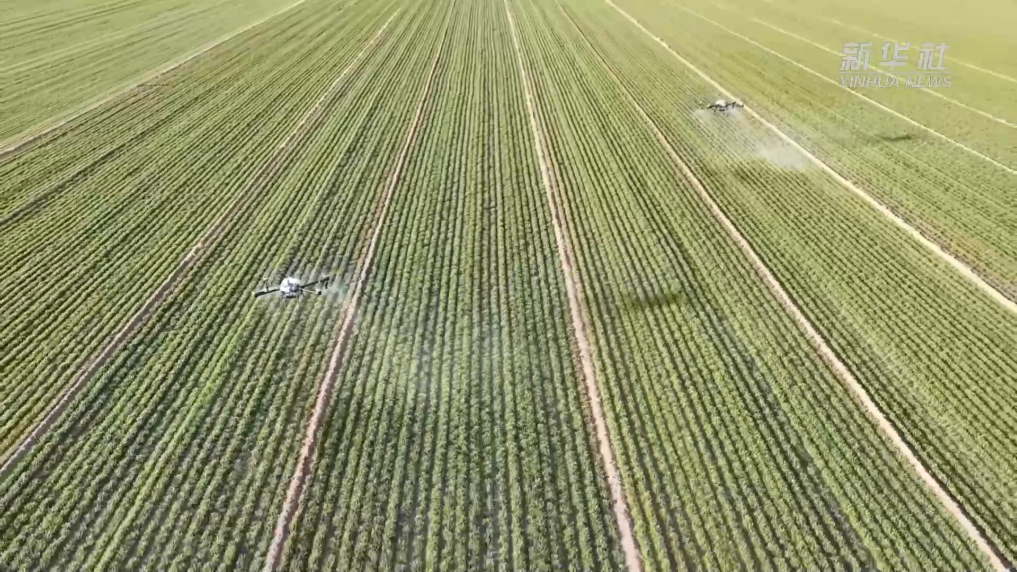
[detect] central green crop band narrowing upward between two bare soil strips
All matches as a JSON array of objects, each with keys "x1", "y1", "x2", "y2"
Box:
[{"x1": 287, "y1": 0, "x2": 620, "y2": 570}]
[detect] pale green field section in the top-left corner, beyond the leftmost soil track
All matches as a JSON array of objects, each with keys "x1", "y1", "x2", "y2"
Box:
[{"x1": 0, "y1": 0, "x2": 296, "y2": 141}]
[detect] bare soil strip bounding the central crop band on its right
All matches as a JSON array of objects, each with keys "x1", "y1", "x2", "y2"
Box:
[{"x1": 504, "y1": 0, "x2": 643, "y2": 572}]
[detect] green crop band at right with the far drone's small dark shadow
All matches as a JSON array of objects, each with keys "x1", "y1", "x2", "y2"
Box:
[{"x1": 618, "y1": 0, "x2": 1017, "y2": 299}]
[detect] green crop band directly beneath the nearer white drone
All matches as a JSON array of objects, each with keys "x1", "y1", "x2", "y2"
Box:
[{"x1": 2, "y1": 0, "x2": 480, "y2": 570}]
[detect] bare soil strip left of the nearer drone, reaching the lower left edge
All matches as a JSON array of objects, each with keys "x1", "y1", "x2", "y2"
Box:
[{"x1": 0, "y1": 10, "x2": 399, "y2": 480}]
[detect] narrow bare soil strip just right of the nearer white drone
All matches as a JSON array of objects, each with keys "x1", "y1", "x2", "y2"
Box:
[{"x1": 264, "y1": 14, "x2": 450, "y2": 572}]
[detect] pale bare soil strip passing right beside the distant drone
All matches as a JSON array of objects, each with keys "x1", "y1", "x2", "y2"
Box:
[{"x1": 604, "y1": 0, "x2": 1017, "y2": 314}]
